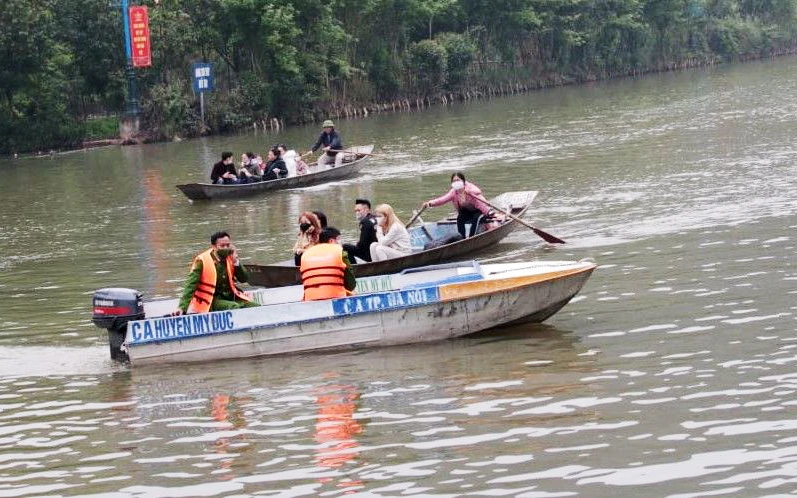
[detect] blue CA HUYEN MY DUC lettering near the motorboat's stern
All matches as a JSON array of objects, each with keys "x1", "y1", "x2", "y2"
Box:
[{"x1": 130, "y1": 311, "x2": 235, "y2": 344}]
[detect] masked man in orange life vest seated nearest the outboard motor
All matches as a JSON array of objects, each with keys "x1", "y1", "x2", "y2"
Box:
[{"x1": 174, "y1": 232, "x2": 258, "y2": 315}]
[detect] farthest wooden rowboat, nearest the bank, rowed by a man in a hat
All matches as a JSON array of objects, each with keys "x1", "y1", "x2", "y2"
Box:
[{"x1": 177, "y1": 145, "x2": 374, "y2": 201}]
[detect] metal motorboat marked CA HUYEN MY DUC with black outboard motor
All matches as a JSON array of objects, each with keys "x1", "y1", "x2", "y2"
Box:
[{"x1": 88, "y1": 261, "x2": 596, "y2": 365}]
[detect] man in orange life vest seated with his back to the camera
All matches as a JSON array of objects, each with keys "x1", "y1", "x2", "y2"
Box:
[{"x1": 299, "y1": 227, "x2": 357, "y2": 301}]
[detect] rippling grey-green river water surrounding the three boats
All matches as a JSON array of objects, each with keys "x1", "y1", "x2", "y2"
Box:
[{"x1": 0, "y1": 58, "x2": 797, "y2": 498}]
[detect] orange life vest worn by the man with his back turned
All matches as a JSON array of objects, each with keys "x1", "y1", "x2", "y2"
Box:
[{"x1": 299, "y1": 244, "x2": 348, "y2": 301}]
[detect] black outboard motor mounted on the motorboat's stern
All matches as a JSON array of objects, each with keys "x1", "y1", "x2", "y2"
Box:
[{"x1": 91, "y1": 287, "x2": 144, "y2": 361}]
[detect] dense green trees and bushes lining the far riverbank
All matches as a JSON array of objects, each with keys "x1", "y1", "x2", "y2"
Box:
[{"x1": 0, "y1": 0, "x2": 797, "y2": 153}]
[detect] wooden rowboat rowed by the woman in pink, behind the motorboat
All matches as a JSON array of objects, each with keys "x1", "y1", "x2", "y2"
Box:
[{"x1": 246, "y1": 191, "x2": 537, "y2": 287}]
